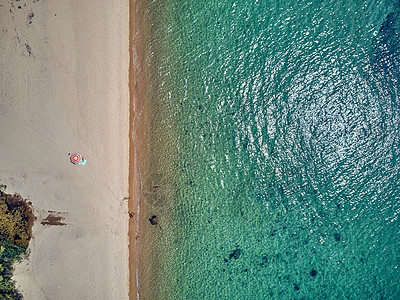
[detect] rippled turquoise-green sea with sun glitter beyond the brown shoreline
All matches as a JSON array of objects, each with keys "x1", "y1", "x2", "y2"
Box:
[{"x1": 144, "y1": 0, "x2": 400, "y2": 299}]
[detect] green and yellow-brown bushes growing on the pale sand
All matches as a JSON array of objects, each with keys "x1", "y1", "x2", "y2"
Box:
[{"x1": 0, "y1": 186, "x2": 34, "y2": 299}]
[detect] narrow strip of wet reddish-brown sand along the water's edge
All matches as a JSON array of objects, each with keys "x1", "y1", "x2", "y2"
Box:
[{"x1": 128, "y1": 0, "x2": 148, "y2": 300}]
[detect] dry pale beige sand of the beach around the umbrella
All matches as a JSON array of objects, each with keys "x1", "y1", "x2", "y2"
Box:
[{"x1": 0, "y1": 0, "x2": 129, "y2": 300}]
